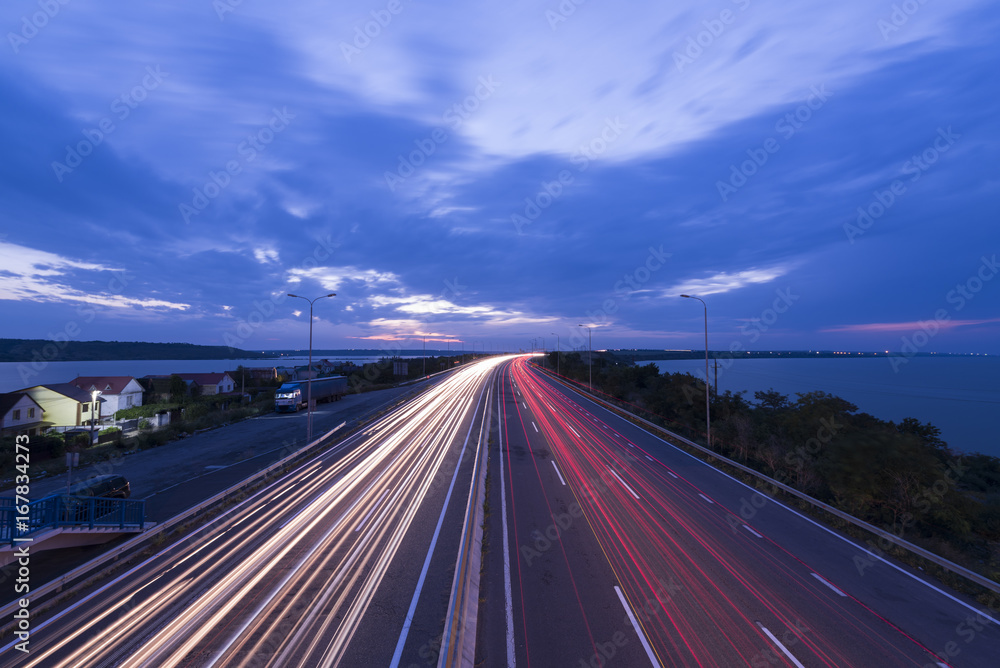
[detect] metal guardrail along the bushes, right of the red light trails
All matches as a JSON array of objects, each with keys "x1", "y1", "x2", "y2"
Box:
[{"x1": 542, "y1": 369, "x2": 1000, "y2": 594}]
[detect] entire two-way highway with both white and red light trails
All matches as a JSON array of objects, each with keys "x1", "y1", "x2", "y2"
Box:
[{"x1": 0, "y1": 356, "x2": 1000, "y2": 668}]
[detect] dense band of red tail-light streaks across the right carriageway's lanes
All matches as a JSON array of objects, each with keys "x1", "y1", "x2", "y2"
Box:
[{"x1": 500, "y1": 363, "x2": 968, "y2": 666}]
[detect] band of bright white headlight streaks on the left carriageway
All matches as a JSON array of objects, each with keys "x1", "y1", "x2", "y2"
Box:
[{"x1": 13, "y1": 358, "x2": 516, "y2": 668}]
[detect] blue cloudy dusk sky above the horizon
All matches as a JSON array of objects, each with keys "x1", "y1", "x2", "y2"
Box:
[{"x1": 0, "y1": 0, "x2": 1000, "y2": 354}]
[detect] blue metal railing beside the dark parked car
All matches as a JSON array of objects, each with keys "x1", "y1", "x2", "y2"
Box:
[{"x1": 0, "y1": 494, "x2": 146, "y2": 544}]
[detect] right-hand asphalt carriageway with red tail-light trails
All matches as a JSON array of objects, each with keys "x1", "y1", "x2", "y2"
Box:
[{"x1": 479, "y1": 358, "x2": 1000, "y2": 667}]
